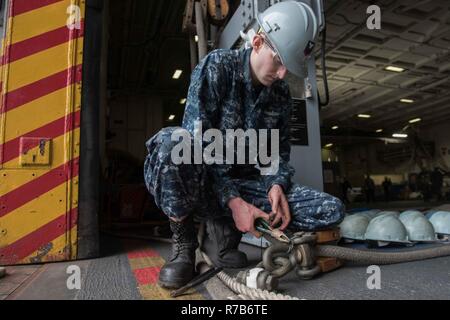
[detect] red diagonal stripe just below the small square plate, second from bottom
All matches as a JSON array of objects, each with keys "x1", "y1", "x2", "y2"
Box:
[{"x1": 0, "y1": 158, "x2": 78, "y2": 218}]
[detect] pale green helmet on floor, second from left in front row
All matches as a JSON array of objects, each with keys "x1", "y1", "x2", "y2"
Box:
[{"x1": 365, "y1": 214, "x2": 410, "y2": 244}]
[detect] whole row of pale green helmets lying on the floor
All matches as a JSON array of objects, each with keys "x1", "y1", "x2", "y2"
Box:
[{"x1": 339, "y1": 210, "x2": 450, "y2": 246}]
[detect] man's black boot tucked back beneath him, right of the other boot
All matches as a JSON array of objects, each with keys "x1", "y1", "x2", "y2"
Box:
[{"x1": 205, "y1": 217, "x2": 248, "y2": 268}]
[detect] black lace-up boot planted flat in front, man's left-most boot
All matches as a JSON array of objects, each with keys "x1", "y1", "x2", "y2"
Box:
[{"x1": 159, "y1": 216, "x2": 198, "y2": 289}]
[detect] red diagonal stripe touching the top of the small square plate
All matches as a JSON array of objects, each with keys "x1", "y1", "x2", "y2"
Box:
[{"x1": 0, "y1": 111, "x2": 80, "y2": 164}]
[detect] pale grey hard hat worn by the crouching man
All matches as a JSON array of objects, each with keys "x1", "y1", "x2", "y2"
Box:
[{"x1": 256, "y1": 1, "x2": 318, "y2": 77}]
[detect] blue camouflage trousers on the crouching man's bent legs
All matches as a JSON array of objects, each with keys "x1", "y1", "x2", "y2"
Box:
[{"x1": 144, "y1": 127, "x2": 345, "y2": 230}]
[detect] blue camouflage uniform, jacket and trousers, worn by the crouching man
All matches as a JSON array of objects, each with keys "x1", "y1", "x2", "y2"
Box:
[{"x1": 144, "y1": 48, "x2": 344, "y2": 230}]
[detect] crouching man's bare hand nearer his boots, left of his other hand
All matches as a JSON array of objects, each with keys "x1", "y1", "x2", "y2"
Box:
[{"x1": 228, "y1": 198, "x2": 269, "y2": 238}]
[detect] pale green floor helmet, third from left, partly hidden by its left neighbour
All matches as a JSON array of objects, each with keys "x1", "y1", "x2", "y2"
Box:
[{"x1": 400, "y1": 211, "x2": 436, "y2": 242}]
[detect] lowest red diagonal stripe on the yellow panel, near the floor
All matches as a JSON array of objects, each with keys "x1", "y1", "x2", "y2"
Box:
[{"x1": 0, "y1": 208, "x2": 78, "y2": 265}]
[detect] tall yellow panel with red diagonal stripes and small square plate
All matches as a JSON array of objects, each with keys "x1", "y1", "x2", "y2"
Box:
[{"x1": 0, "y1": 0, "x2": 85, "y2": 265}]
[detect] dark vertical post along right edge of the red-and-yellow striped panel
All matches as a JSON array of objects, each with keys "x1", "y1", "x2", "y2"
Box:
[{"x1": 77, "y1": 0, "x2": 103, "y2": 259}]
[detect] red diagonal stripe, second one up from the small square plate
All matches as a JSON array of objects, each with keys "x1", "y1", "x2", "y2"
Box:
[{"x1": 0, "y1": 65, "x2": 82, "y2": 113}]
